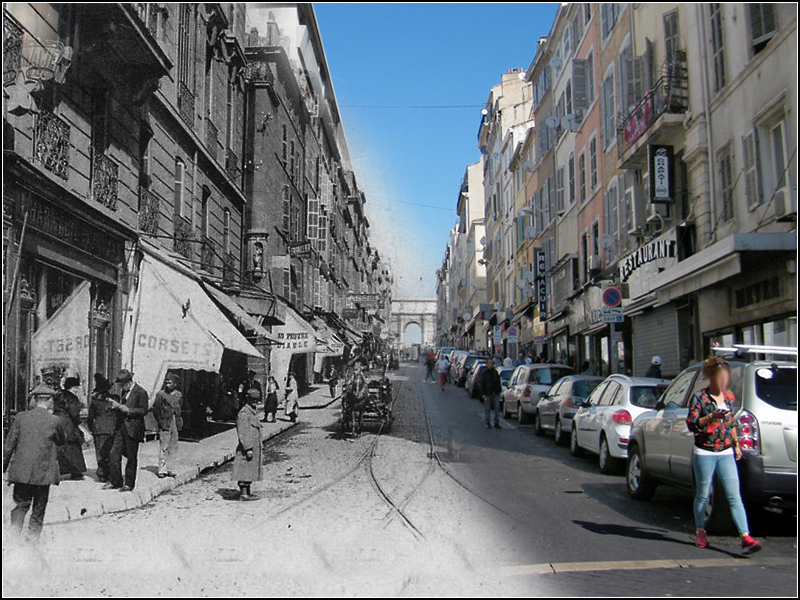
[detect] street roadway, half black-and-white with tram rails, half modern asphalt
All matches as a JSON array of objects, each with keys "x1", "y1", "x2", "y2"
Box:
[{"x1": 3, "y1": 363, "x2": 797, "y2": 596}]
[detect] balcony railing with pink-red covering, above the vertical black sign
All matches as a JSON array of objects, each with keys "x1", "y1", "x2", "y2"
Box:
[{"x1": 617, "y1": 76, "x2": 689, "y2": 156}]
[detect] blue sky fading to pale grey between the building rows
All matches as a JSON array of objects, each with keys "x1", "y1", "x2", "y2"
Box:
[{"x1": 315, "y1": 3, "x2": 557, "y2": 298}]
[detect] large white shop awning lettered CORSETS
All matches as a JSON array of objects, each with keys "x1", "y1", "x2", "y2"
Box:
[{"x1": 122, "y1": 253, "x2": 264, "y2": 398}]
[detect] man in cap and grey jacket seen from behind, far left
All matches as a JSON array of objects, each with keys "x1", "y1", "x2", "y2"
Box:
[{"x1": 3, "y1": 384, "x2": 67, "y2": 540}]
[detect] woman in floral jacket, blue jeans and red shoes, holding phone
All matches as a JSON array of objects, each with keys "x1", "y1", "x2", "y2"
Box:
[{"x1": 686, "y1": 357, "x2": 761, "y2": 554}]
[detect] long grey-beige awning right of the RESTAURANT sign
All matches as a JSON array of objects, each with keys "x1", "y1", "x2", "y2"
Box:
[{"x1": 652, "y1": 232, "x2": 797, "y2": 303}]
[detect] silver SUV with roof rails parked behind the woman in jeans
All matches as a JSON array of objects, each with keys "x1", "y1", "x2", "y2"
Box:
[{"x1": 625, "y1": 349, "x2": 797, "y2": 531}]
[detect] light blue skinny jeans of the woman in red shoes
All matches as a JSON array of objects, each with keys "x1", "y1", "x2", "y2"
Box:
[{"x1": 692, "y1": 453, "x2": 749, "y2": 535}]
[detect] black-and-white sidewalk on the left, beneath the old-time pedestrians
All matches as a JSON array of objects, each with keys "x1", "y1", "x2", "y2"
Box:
[{"x1": 3, "y1": 386, "x2": 333, "y2": 523}]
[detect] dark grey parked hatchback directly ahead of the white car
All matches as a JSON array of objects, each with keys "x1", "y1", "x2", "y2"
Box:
[{"x1": 536, "y1": 375, "x2": 603, "y2": 446}]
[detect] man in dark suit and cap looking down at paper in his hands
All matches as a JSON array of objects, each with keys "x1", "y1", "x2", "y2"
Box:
[{"x1": 103, "y1": 369, "x2": 150, "y2": 492}]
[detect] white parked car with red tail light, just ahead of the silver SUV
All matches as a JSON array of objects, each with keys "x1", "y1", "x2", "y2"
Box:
[{"x1": 569, "y1": 375, "x2": 670, "y2": 474}]
